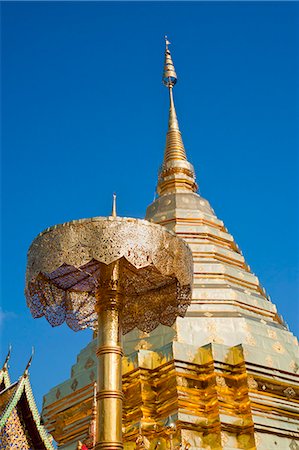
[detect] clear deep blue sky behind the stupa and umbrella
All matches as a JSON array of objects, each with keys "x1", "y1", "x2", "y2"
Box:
[{"x1": 1, "y1": 2, "x2": 299, "y2": 414}]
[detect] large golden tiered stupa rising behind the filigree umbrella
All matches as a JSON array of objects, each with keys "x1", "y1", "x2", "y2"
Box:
[{"x1": 42, "y1": 39, "x2": 299, "y2": 450}]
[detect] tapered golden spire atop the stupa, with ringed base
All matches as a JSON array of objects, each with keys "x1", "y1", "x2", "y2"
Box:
[{"x1": 157, "y1": 36, "x2": 197, "y2": 195}]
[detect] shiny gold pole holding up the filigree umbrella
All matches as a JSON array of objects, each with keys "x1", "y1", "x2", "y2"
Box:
[{"x1": 95, "y1": 262, "x2": 123, "y2": 450}]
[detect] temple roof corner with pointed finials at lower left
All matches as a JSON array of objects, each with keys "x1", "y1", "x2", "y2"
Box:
[{"x1": 0, "y1": 359, "x2": 54, "y2": 450}]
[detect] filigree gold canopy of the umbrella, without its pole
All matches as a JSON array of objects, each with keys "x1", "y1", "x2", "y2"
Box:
[{"x1": 25, "y1": 217, "x2": 193, "y2": 334}]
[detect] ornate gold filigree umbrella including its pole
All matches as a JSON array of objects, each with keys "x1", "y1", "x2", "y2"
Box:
[{"x1": 25, "y1": 217, "x2": 193, "y2": 449}]
